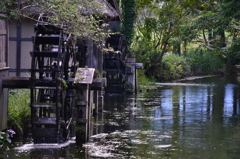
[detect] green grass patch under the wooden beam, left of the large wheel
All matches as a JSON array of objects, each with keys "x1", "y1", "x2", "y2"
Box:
[{"x1": 8, "y1": 89, "x2": 31, "y2": 135}]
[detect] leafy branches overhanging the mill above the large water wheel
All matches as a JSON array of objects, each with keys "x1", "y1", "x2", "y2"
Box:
[{"x1": 0, "y1": 0, "x2": 109, "y2": 46}]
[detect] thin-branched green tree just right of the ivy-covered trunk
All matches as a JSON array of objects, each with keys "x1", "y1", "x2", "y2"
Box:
[{"x1": 133, "y1": 0, "x2": 195, "y2": 76}]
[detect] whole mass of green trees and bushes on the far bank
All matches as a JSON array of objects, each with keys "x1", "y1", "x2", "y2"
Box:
[{"x1": 131, "y1": 0, "x2": 240, "y2": 81}]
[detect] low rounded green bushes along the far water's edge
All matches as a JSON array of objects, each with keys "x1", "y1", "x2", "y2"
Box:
[{"x1": 142, "y1": 48, "x2": 226, "y2": 82}]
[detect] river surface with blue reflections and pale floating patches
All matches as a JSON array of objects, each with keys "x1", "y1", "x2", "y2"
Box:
[{"x1": 0, "y1": 78, "x2": 240, "y2": 159}]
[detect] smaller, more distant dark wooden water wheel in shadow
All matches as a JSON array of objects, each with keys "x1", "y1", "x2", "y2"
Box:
[{"x1": 103, "y1": 34, "x2": 127, "y2": 93}]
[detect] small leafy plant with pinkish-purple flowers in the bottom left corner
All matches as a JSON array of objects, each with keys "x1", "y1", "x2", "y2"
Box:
[{"x1": 0, "y1": 129, "x2": 16, "y2": 152}]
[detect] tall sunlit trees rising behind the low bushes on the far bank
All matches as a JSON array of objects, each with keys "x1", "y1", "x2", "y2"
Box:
[{"x1": 133, "y1": 0, "x2": 240, "y2": 79}]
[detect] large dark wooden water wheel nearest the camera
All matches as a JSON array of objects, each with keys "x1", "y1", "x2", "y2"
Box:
[{"x1": 30, "y1": 24, "x2": 76, "y2": 143}]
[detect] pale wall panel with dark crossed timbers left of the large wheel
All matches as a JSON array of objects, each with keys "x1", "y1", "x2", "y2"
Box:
[{"x1": 9, "y1": 19, "x2": 35, "y2": 77}]
